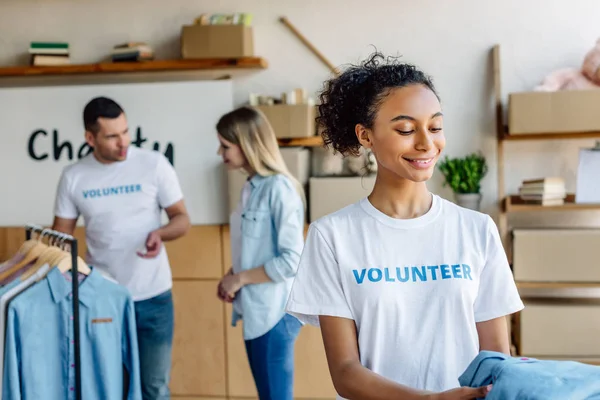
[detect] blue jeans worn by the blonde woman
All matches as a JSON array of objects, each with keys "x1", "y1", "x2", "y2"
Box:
[{"x1": 246, "y1": 314, "x2": 302, "y2": 400}]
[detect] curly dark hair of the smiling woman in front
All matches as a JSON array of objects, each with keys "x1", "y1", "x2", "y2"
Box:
[{"x1": 317, "y1": 51, "x2": 439, "y2": 155}]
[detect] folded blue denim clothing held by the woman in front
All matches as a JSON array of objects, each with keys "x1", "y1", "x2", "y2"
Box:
[{"x1": 458, "y1": 351, "x2": 600, "y2": 400}]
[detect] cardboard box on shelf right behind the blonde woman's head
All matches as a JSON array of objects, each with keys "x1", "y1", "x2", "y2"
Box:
[{"x1": 256, "y1": 104, "x2": 316, "y2": 138}]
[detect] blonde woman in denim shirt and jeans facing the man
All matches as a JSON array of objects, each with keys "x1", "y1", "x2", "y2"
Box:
[{"x1": 217, "y1": 107, "x2": 304, "y2": 400}]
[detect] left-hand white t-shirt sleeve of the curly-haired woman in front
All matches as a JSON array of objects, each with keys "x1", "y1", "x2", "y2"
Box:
[{"x1": 286, "y1": 223, "x2": 354, "y2": 326}]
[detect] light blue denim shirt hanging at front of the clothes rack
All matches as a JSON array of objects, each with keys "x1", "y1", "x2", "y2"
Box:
[{"x1": 2, "y1": 268, "x2": 142, "y2": 400}]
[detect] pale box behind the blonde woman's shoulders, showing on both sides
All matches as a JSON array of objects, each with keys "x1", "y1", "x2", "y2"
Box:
[{"x1": 227, "y1": 147, "x2": 310, "y2": 213}]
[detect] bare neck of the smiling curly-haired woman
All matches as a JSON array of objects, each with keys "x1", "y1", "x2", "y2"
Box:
[{"x1": 369, "y1": 170, "x2": 432, "y2": 219}]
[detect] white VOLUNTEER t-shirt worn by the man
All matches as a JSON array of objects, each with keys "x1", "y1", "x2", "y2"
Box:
[{"x1": 54, "y1": 146, "x2": 183, "y2": 301}]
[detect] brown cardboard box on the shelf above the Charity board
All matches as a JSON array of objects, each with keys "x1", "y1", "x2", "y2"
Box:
[{"x1": 181, "y1": 25, "x2": 254, "y2": 59}]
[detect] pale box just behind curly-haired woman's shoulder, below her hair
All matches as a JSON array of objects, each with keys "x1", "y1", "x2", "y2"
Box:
[{"x1": 308, "y1": 176, "x2": 375, "y2": 222}]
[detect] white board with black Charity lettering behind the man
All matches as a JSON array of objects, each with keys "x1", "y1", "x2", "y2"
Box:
[{"x1": 0, "y1": 81, "x2": 233, "y2": 226}]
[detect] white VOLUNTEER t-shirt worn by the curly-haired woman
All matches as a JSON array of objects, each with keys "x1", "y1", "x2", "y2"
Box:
[{"x1": 287, "y1": 195, "x2": 523, "y2": 398}]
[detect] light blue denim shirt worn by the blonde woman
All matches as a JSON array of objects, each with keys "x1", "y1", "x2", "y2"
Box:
[{"x1": 232, "y1": 174, "x2": 304, "y2": 340}]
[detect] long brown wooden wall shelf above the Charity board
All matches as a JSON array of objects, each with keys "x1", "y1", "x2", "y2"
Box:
[{"x1": 0, "y1": 57, "x2": 268, "y2": 78}]
